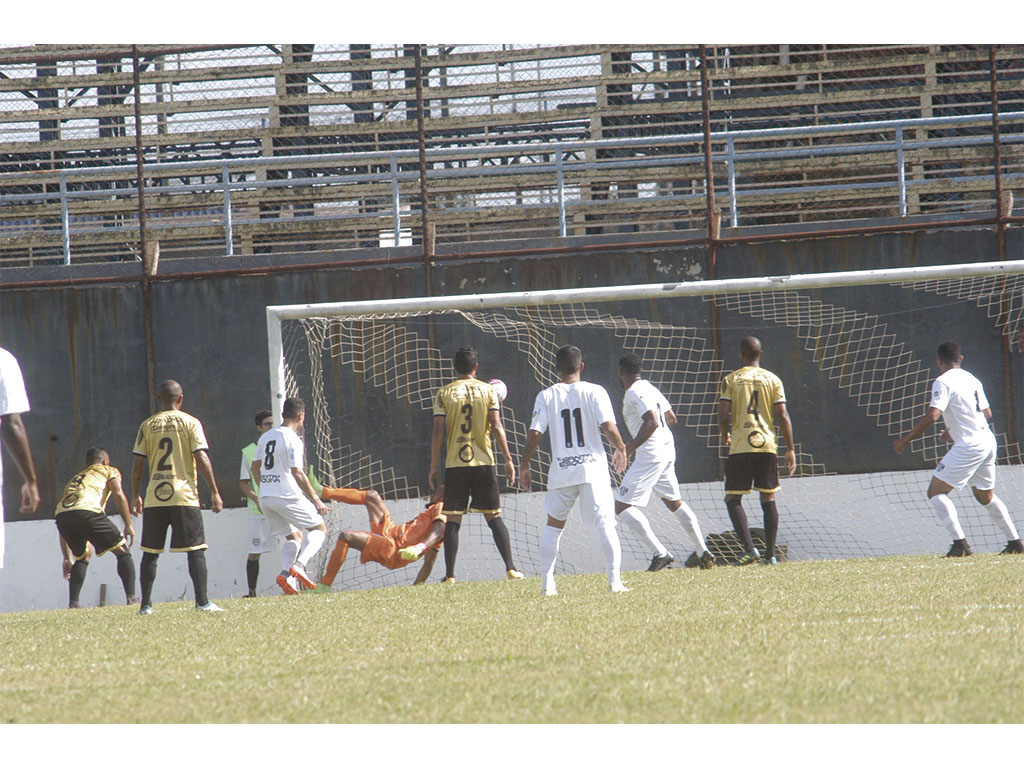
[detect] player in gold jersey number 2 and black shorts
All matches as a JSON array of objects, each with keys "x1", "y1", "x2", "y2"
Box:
[{"x1": 131, "y1": 379, "x2": 224, "y2": 615}]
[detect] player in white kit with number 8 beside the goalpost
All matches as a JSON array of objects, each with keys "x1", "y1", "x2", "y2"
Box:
[{"x1": 252, "y1": 397, "x2": 327, "y2": 595}]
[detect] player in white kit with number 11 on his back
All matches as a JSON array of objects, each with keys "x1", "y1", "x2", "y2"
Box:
[{"x1": 519, "y1": 346, "x2": 629, "y2": 595}]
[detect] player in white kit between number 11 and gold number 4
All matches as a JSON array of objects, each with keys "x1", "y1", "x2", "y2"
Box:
[{"x1": 615, "y1": 354, "x2": 715, "y2": 570}]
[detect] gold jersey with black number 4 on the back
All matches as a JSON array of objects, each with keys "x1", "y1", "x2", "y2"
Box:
[{"x1": 719, "y1": 366, "x2": 785, "y2": 454}]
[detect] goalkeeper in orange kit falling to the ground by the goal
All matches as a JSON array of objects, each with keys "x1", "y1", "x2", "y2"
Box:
[{"x1": 317, "y1": 485, "x2": 446, "y2": 591}]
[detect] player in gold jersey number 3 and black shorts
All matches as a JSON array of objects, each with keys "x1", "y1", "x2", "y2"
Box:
[{"x1": 430, "y1": 347, "x2": 523, "y2": 582}]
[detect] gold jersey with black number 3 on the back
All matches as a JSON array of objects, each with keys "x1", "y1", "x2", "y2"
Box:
[{"x1": 434, "y1": 379, "x2": 501, "y2": 467}]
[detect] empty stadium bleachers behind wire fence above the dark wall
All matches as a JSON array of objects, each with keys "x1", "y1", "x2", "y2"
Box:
[{"x1": 0, "y1": 45, "x2": 1024, "y2": 266}]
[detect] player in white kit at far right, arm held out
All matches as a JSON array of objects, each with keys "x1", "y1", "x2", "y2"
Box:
[{"x1": 893, "y1": 341, "x2": 1024, "y2": 557}]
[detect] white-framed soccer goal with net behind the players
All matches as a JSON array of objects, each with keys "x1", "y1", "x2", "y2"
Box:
[{"x1": 267, "y1": 261, "x2": 1024, "y2": 589}]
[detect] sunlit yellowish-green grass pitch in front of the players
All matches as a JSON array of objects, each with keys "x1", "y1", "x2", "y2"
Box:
[{"x1": 0, "y1": 555, "x2": 1024, "y2": 723}]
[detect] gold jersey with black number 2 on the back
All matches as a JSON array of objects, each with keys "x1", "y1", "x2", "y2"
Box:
[{"x1": 132, "y1": 410, "x2": 209, "y2": 507}]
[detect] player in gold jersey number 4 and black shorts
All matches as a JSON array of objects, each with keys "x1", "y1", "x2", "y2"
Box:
[{"x1": 718, "y1": 336, "x2": 797, "y2": 565}]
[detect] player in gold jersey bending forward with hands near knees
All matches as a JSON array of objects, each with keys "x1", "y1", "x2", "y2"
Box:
[{"x1": 55, "y1": 447, "x2": 138, "y2": 608}]
